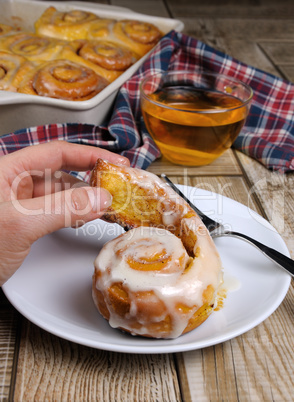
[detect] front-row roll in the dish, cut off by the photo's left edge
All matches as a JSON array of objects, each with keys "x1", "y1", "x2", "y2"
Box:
[{"x1": 0, "y1": 51, "x2": 34, "y2": 92}]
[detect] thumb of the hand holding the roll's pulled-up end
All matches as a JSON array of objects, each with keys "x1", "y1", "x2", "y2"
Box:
[{"x1": 13, "y1": 187, "x2": 112, "y2": 243}]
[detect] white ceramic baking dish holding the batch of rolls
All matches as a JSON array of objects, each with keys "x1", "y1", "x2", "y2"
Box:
[{"x1": 0, "y1": 0, "x2": 184, "y2": 135}]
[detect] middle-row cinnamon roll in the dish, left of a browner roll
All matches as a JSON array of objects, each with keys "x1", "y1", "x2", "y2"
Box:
[{"x1": 0, "y1": 32, "x2": 72, "y2": 61}]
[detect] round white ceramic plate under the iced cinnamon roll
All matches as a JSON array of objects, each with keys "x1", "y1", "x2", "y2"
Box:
[{"x1": 3, "y1": 186, "x2": 291, "y2": 353}]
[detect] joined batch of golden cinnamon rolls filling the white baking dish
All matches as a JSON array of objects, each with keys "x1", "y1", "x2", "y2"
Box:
[{"x1": 0, "y1": 6, "x2": 163, "y2": 101}]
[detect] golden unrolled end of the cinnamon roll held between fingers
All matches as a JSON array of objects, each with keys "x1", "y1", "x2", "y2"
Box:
[{"x1": 90, "y1": 159, "x2": 200, "y2": 255}]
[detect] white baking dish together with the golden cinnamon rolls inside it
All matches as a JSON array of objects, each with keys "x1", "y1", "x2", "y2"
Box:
[{"x1": 0, "y1": 0, "x2": 183, "y2": 135}]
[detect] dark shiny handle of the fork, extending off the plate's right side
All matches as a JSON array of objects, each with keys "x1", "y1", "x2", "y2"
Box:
[{"x1": 211, "y1": 231, "x2": 294, "y2": 278}]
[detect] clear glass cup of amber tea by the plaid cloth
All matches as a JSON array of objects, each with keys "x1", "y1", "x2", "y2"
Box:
[{"x1": 140, "y1": 71, "x2": 253, "y2": 166}]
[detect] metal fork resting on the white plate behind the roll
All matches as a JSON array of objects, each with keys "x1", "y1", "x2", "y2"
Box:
[{"x1": 161, "y1": 174, "x2": 294, "y2": 277}]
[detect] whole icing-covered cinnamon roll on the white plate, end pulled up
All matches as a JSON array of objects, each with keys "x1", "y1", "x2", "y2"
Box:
[{"x1": 91, "y1": 160, "x2": 222, "y2": 338}]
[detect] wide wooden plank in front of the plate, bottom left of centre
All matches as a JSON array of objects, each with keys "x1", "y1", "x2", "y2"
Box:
[{"x1": 14, "y1": 322, "x2": 180, "y2": 402}]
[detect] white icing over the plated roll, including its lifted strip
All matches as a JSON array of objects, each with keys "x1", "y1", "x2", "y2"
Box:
[{"x1": 94, "y1": 168, "x2": 222, "y2": 338}]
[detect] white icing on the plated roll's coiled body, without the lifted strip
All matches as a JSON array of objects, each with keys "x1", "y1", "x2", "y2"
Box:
[{"x1": 95, "y1": 227, "x2": 220, "y2": 338}]
